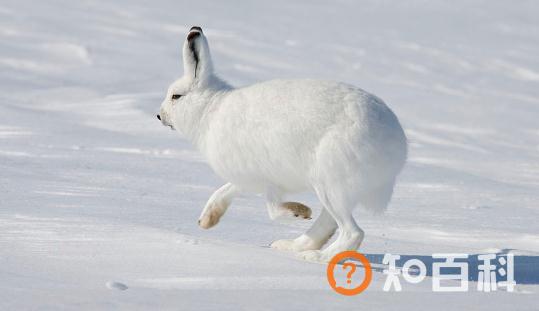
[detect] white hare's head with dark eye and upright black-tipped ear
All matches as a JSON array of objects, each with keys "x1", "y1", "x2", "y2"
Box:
[{"x1": 157, "y1": 26, "x2": 215, "y2": 129}]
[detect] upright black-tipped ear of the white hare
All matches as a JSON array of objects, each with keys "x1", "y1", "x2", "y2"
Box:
[{"x1": 183, "y1": 26, "x2": 213, "y2": 83}]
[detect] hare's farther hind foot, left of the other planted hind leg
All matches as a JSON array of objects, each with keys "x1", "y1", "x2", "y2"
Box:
[{"x1": 271, "y1": 208, "x2": 337, "y2": 252}]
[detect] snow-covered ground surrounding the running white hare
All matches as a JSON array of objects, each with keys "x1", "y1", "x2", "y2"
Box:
[{"x1": 0, "y1": 0, "x2": 539, "y2": 310}]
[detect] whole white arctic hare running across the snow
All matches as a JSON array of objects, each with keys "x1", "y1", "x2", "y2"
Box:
[{"x1": 157, "y1": 27, "x2": 407, "y2": 261}]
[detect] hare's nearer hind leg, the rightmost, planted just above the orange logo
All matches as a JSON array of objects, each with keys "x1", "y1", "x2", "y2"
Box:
[{"x1": 300, "y1": 185, "x2": 364, "y2": 262}]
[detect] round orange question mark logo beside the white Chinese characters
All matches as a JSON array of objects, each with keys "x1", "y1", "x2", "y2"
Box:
[{"x1": 327, "y1": 251, "x2": 372, "y2": 296}]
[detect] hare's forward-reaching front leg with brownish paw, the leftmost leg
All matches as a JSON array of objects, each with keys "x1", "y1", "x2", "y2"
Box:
[{"x1": 198, "y1": 183, "x2": 240, "y2": 229}]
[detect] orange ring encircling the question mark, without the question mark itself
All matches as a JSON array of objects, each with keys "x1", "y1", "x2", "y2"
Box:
[{"x1": 327, "y1": 251, "x2": 372, "y2": 296}]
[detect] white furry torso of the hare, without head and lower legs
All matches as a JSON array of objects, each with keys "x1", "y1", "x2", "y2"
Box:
[{"x1": 199, "y1": 80, "x2": 406, "y2": 199}]
